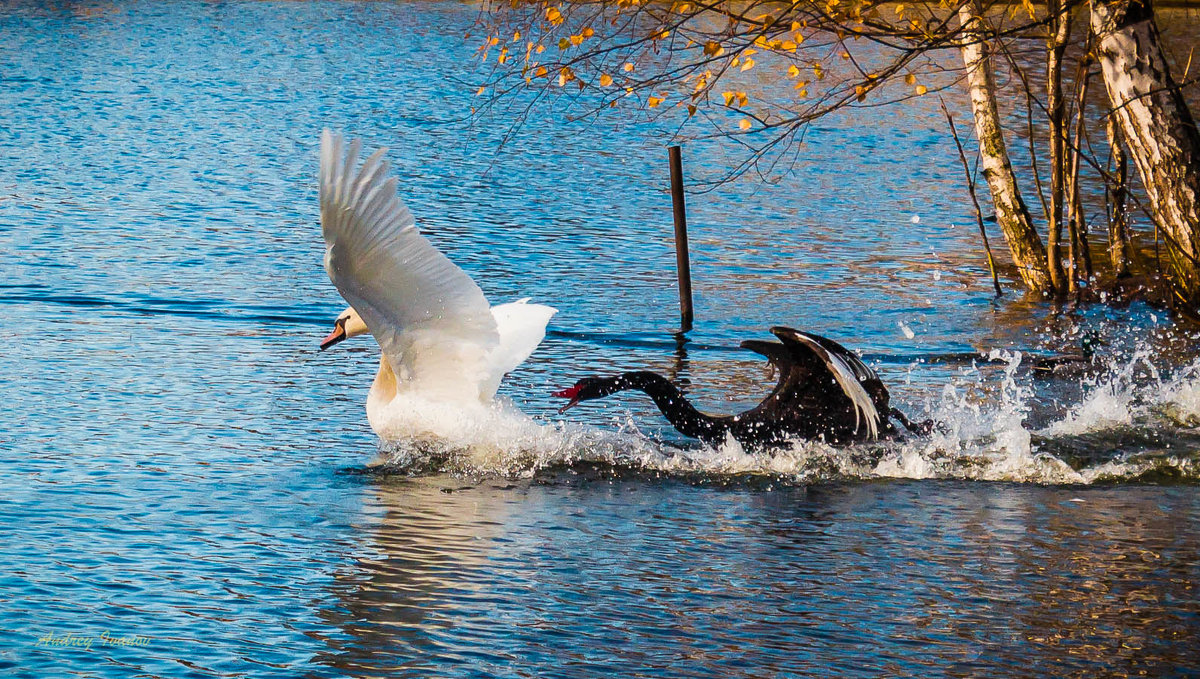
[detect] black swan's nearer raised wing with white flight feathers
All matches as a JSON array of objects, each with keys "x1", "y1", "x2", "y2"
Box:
[{"x1": 770, "y1": 326, "x2": 888, "y2": 438}]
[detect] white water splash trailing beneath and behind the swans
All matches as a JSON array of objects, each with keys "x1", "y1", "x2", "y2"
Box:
[{"x1": 369, "y1": 349, "x2": 1200, "y2": 483}]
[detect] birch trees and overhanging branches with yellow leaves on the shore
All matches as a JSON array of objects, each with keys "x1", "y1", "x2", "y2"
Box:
[{"x1": 477, "y1": 0, "x2": 1200, "y2": 323}]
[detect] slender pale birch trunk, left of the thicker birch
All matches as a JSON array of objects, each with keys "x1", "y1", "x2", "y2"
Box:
[{"x1": 959, "y1": 0, "x2": 1054, "y2": 294}]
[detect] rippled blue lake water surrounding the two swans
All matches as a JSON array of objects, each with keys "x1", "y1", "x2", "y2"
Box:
[{"x1": 0, "y1": 2, "x2": 1200, "y2": 678}]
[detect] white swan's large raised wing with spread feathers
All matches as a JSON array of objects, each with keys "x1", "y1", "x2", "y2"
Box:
[{"x1": 320, "y1": 130, "x2": 499, "y2": 398}]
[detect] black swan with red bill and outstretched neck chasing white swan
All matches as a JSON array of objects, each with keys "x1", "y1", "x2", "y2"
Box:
[{"x1": 554, "y1": 326, "x2": 934, "y2": 446}]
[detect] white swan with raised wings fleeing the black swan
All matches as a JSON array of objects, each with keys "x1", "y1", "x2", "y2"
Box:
[{"x1": 319, "y1": 130, "x2": 557, "y2": 439}]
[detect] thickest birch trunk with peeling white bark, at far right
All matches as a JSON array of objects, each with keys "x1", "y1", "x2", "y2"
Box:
[{"x1": 1092, "y1": 0, "x2": 1200, "y2": 304}]
